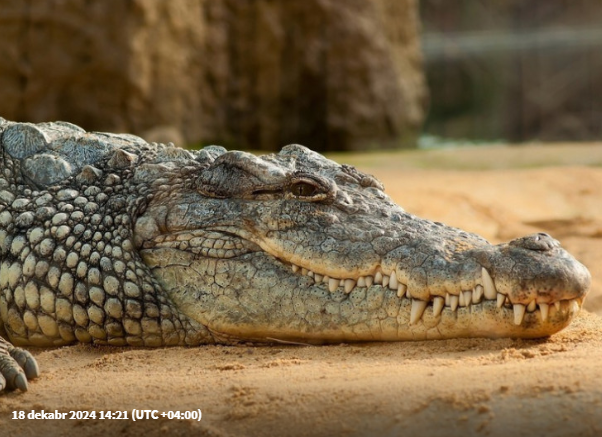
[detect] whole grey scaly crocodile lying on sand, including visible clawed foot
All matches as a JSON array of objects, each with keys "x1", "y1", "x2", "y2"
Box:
[{"x1": 0, "y1": 118, "x2": 591, "y2": 390}]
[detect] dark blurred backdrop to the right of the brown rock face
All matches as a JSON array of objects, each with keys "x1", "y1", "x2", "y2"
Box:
[{"x1": 420, "y1": 0, "x2": 602, "y2": 142}]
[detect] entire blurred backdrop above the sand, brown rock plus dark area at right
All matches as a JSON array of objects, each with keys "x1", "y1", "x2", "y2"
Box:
[{"x1": 0, "y1": 0, "x2": 602, "y2": 151}]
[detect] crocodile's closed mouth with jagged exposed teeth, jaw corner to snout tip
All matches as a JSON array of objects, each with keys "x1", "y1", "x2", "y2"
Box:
[{"x1": 140, "y1": 230, "x2": 583, "y2": 338}]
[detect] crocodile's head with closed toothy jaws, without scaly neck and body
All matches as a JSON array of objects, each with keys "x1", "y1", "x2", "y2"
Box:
[{"x1": 135, "y1": 145, "x2": 590, "y2": 342}]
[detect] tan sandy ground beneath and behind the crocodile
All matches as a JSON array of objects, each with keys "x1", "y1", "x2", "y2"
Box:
[{"x1": 0, "y1": 146, "x2": 602, "y2": 436}]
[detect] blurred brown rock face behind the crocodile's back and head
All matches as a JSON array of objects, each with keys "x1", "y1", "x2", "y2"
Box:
[{"x1": 0, "y1": 0, "x2": 426, "y2": 151}]
